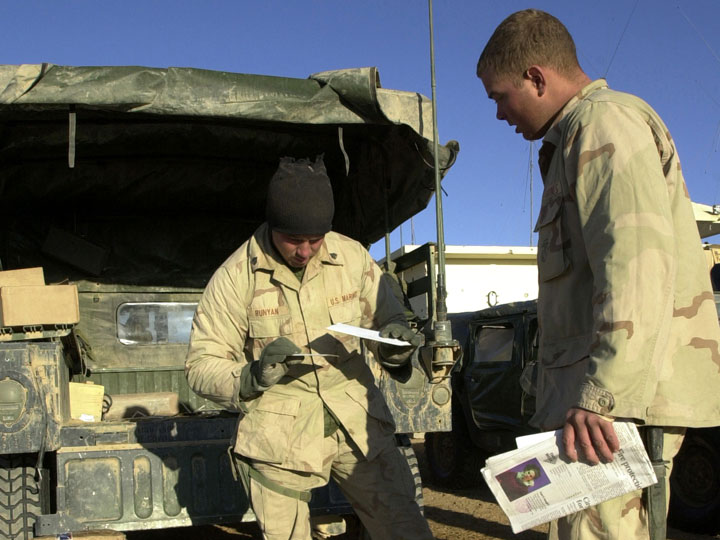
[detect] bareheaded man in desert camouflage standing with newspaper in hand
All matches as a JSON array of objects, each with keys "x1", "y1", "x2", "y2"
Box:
[{"x1": 477, "y1": 10, "x2": 720, "y2": 539}]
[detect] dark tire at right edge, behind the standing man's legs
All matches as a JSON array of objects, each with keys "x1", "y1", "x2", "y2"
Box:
[{"x1": 668, "y1": 428, "x2": 720, "y2": 534}]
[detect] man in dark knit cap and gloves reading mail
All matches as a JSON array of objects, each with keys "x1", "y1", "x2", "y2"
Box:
[{"x1": 186, "y1": 159, "x2": 432, "y2": 540}]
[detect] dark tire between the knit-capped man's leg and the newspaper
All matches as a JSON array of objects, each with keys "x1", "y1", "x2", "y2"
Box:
[{"x1": 425, "y1": 417, "x2": 487, "y2": 489}]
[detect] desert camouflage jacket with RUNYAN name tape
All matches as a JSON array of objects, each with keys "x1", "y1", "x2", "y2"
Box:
[{"x1": 186, "y1": 225, "x2": 405, "y2": 472}]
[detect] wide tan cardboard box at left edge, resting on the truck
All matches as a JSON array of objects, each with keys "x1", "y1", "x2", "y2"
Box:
[{"x1": 0, "y1": 285, "x2": 80, "y2": 327}]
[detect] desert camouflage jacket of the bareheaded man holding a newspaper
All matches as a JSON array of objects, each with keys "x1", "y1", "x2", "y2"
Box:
[{"x1": 533, "y1": 80, "x2": 720, "y2": 429}]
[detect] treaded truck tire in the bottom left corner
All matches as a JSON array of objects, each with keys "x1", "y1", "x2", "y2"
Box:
[{"x1": 0, "y1": 455, "x2": 42, "y2": 540}]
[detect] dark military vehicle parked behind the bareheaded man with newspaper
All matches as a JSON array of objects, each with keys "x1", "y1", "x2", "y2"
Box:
[{"x1": 425, "y1": 282, "x2": 720, "y2": 534}]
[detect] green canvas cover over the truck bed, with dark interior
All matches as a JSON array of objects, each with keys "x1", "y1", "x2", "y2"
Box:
[{"x1": 0, "y1": 64, "x2": 458, "y2": 286}]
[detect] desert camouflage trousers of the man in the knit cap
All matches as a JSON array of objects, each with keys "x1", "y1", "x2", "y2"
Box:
[{"x1": 250, "y1": 429, "x2": 433, "y2": 540}]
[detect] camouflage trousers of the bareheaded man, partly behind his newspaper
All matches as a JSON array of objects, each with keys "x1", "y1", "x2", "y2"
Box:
[{"x1": 548, "y1": 427, "x2": 685, "y2": 540}]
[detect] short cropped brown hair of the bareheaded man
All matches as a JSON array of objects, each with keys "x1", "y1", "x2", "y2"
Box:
[{"x1": 477, "y1": 9, "x2": 580, "y2": 85}]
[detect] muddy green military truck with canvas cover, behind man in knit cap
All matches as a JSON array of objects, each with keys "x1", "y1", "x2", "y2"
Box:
[{"x1": 0, "y1": 64, "x2": 458, "y2": 539}]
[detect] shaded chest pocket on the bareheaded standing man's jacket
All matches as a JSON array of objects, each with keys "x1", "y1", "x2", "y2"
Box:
[{"x1": 535, "y1": 184, "x2": 570, "y2": 281}]
